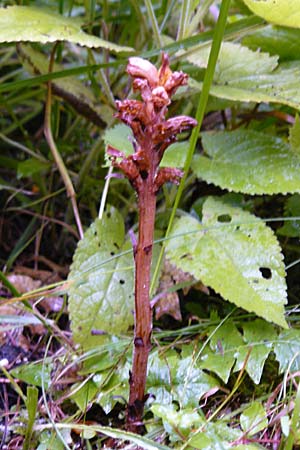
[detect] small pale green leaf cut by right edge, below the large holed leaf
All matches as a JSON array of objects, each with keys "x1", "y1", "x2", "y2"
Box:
[{"x1": 274, "y1": 329, "x2": 300, "y2": 373}]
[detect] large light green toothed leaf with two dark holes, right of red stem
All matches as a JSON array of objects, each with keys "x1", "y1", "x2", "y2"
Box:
[{"x1": 166, "y1": 198, "x2": 287, "y2": 327}]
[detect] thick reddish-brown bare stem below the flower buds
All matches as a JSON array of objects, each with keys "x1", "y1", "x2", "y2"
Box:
[{"x1": 127, "y1": 156, "x2": 158, "y2": 433}]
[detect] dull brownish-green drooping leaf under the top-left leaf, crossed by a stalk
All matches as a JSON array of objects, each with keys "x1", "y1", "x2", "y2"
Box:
[{"x1": 18, "y1": 44, "x2": 111, "y2": 126}]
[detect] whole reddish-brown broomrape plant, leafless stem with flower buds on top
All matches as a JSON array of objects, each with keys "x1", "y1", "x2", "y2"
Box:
[{"x1": 108, "y1": 53, "x2": 197, "y2": 431}]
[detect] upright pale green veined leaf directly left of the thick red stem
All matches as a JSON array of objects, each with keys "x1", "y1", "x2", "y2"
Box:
[{"x1": 68, "y1": 208, "x2": 134, "y2": 347}]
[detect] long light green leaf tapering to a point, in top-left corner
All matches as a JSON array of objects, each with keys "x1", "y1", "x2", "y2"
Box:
[{"x1": 0, "y1": 5, "x2": 133, "y2": 53}]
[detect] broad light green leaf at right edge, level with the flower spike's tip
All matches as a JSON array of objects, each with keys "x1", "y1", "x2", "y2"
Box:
[{"x1": 187, "y1": 42, "x2": 300, "y2": 109}]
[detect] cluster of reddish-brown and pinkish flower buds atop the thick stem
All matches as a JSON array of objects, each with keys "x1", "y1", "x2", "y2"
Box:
[{"x1": 108, "y1": 53, "x2": 197, "y2": 192}]
